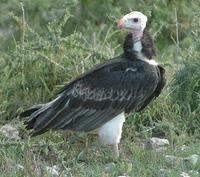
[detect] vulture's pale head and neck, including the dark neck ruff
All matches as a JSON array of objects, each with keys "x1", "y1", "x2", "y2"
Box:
[{"x1": 117, "y1": 11, "x2": 155, "y2": 59}]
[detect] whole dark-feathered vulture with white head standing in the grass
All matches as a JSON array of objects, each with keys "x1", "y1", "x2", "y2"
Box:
[{"x1": 21, "y1": 11, "x2": 166, "y2": 156}]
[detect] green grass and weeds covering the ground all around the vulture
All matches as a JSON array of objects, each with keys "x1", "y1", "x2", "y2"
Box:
[{"x1": 0, "y1": 0, "x2": 200, "y2": 177}]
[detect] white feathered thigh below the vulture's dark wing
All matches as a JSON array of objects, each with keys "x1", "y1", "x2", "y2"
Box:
[{"x1": 98, "y1": 112, "x2": 125, "y2": 145}]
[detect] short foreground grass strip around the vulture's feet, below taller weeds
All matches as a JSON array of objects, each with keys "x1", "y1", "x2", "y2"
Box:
[{"x1": 0, "y1": 130, "x2": 200, "y2": 177}]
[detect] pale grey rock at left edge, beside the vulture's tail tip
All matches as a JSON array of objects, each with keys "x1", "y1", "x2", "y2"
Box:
[{"x1": 0, "y1": 124, "x2": 20, "y2": 139}]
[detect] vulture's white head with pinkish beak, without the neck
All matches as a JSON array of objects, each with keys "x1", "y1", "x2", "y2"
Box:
[{"x1": 118, "y1": 11, "x2": 147, "y2": 32}]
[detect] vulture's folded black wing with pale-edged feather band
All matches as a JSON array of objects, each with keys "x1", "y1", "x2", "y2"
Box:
[{"x1": 21, "y1": 59, "x2": 164, "y2": 135}]
